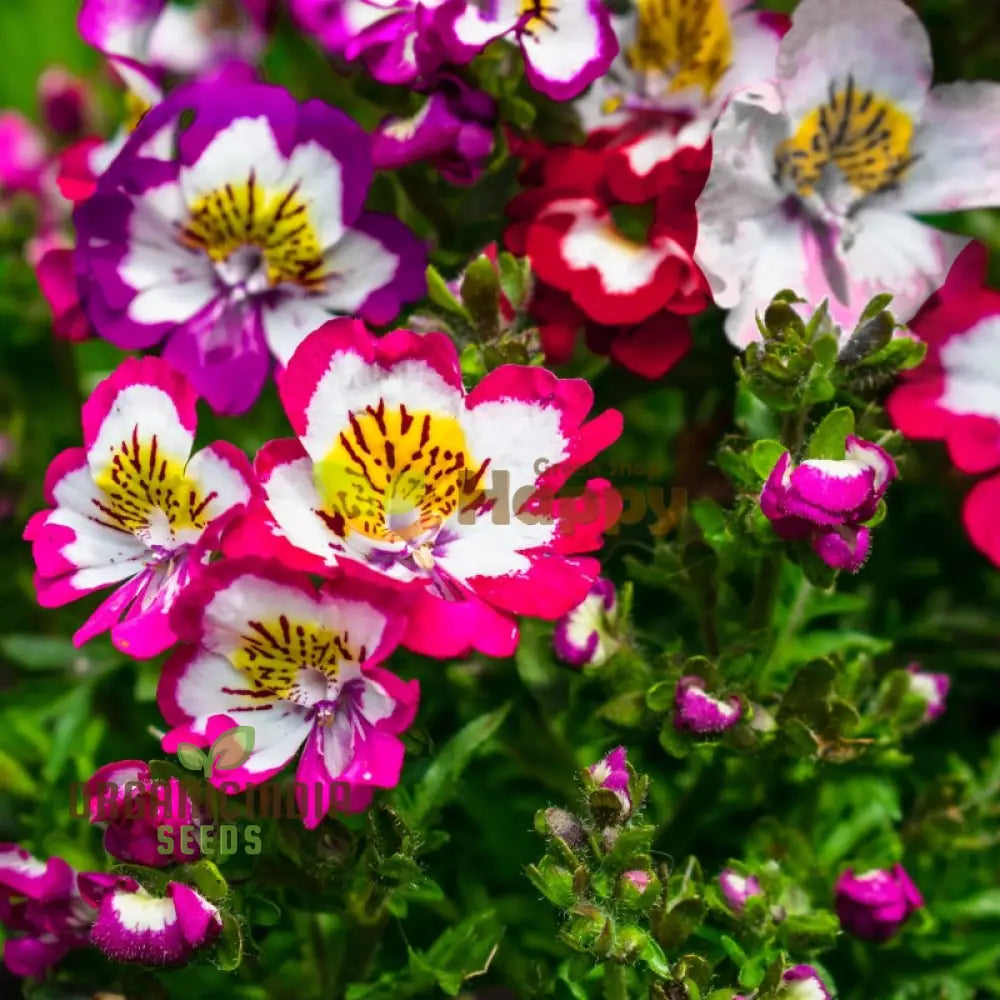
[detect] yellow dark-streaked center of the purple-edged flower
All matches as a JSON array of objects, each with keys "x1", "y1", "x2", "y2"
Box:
[{"x1": 181, "y1": 171, "x2": 323, "y2": 291}]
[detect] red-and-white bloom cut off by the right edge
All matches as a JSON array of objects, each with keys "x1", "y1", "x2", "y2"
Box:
[{"x1": 886, "y1": 243, "x2": 1000, "y2": 565}]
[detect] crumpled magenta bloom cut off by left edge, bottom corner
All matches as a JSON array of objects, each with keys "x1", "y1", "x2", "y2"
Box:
[{"x1": 0, "y1": 844, "x2": 94, "y2": 979}]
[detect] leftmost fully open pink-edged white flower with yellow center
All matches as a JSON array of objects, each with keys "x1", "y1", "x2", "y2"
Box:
[{"x1": 24, "y1": 358, "x2": 251, "y2": 658}]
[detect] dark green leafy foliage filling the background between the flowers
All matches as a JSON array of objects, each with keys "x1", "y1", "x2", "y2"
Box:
[{"x1": 0, "y1": 0, "x2": 1000, "y2": 1000}]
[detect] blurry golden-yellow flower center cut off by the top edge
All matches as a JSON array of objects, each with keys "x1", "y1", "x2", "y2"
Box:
[{"x1": 626, "y1": 0, "x2": 733, "y2": 97}]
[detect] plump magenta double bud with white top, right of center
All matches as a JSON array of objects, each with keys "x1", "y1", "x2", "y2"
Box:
[{"x1": 760, "y1": 435, "x2": 898, "y2": 573}]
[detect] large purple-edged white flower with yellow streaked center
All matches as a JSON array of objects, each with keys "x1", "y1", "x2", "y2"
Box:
[{"x1": 74, "y1": 77, "x2": 425, "y2": 413}]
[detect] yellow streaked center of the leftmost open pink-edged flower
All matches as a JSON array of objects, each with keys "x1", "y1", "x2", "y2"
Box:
[{"x1": 93, "y1": 428, "x2": 217, "y2": 536}]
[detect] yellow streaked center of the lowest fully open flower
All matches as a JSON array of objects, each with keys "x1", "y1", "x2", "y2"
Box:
[{"x1": 231, "y1": 615, "x2": 368, "y2": 702}]
